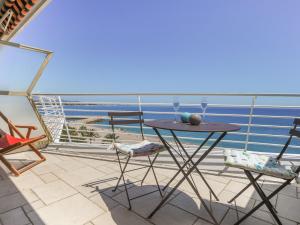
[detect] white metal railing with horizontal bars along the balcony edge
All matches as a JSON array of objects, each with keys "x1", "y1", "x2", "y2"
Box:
[{"x1": 34, "y1": 93, "x2": 300, "y2": 153}]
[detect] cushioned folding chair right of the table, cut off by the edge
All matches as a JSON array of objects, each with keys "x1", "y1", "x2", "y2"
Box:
[{"x1": 224, "y1": 119, "x2": 300, "y2": 225}]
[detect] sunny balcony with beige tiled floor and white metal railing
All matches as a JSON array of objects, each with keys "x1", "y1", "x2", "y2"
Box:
[{"x1": 0, "y1": 93, "x2": 300, "y2": 225}]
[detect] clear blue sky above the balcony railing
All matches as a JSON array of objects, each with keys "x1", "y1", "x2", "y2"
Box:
[{"x1": 13, "y1": 0, "x2": 300, "y2": 93}]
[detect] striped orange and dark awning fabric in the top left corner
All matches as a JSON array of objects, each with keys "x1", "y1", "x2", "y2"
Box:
[{"x1": 0, "y1": 0, "x2": 38, "y2": 37}]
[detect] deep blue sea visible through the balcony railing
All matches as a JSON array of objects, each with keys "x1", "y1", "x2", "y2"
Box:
[{"x1": 64, "y1": 105, "x2": 300, "y2": 154}]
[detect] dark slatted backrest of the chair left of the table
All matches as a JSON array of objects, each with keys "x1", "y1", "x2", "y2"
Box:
[{"x1": 108, "y1": 111, "x2": 145, "y2": 141}]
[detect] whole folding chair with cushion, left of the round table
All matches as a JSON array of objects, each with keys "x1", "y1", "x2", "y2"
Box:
[{"x1": 108, "y1": 112, "x2": 165, "y2": 210}]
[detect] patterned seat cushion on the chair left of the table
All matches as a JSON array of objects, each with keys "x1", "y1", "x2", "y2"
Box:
[{"x1": 114, "y1": 140, "x2": 165, "y2": 157}]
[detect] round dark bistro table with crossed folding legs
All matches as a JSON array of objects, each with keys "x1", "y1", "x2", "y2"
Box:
[{"x1": 144, "y1": 120, "x2": 240, "y2": 224}]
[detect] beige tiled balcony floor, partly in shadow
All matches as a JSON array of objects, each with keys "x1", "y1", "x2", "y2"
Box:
[{"x1": 0, "y1": 148, "x2": 300, "y2": 225}]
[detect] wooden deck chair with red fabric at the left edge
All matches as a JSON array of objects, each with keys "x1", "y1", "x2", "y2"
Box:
[{"x1": 0, "y1": 112, "x2": 46, "y2": 176}]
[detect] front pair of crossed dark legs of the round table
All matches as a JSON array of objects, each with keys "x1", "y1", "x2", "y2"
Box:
[{"x1": 148, "y1": 128, "x2": 227, "y2": 224}]
